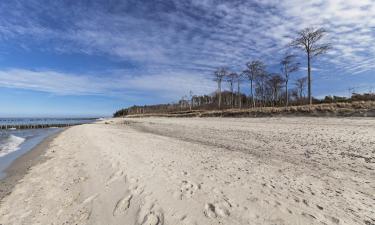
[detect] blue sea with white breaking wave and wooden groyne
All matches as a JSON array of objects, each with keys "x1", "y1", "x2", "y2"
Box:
[{"x1": 0, "y1": 118, "x2": 98, "y2": 179}]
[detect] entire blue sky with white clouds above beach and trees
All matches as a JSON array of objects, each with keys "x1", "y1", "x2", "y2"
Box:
[{"x1": 0, "y1": 0, "x2": 375, "y2": 116}]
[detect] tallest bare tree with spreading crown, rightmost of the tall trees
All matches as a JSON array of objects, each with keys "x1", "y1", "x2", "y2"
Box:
[{"x1": 291, "y1": 27, "x2": 330, "y2": 105}]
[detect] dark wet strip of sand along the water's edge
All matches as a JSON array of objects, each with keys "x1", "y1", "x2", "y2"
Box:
[{"x1": 0, "y1": 128, "x2": 66, "y2": 201}]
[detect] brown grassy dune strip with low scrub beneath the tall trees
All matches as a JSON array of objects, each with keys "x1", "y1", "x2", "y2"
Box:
[{"x1": 114, "y1": 92, "x2": 375, "y2": 117}]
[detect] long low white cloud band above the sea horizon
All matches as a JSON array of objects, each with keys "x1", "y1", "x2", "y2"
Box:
[{"x1": 0, "y1": 69, "x2": 212, "y2": 100}]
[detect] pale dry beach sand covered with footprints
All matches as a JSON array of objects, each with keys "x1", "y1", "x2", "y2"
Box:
[{"x1": 0, "y1": 117, "x2": 375, "y2": 225}]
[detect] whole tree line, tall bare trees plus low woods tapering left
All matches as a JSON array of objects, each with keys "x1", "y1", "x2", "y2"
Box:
[{"x1": 115, "y1": 28, "x2": 374, "y2": 116}]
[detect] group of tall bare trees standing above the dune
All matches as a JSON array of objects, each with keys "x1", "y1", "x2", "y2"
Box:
[{"x1": 213, "y1": 28, "x2": 330, "y2": 109}]
